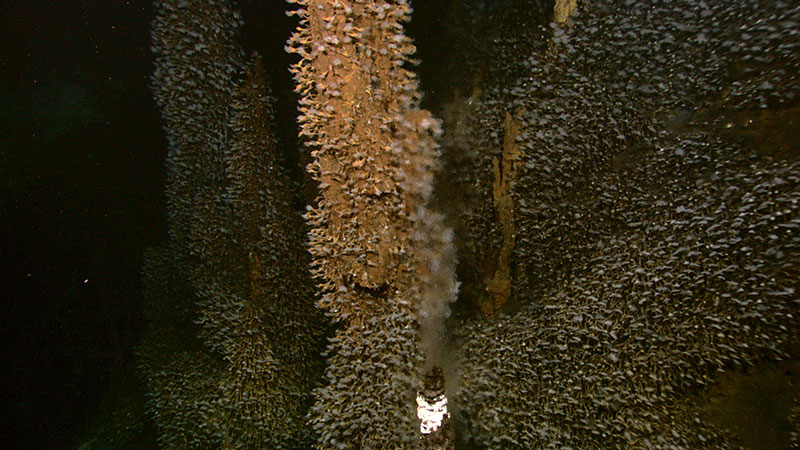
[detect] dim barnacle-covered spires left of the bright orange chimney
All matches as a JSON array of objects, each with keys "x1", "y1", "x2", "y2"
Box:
[{"x1": 141, "y1": 0, "x2": 321, "y2": 448}]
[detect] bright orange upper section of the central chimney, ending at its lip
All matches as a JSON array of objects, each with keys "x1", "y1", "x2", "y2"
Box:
[{"x1": 291, "y1": 1, "x2": 439, "y2": 320}]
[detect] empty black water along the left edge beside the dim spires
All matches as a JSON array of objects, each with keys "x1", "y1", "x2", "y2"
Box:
[{"x1": 0, "y1": 1, "x2": 166, "y2": 448}]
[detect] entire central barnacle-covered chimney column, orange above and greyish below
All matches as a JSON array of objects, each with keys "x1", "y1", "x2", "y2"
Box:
[{"x1": 287, "y1": 0, "x2": 454, "y2": 448}]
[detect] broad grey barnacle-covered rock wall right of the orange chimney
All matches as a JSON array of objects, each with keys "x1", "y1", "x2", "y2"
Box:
[{"x1": 445, "y1": 1, "x2": 800, "y2": 448}]
